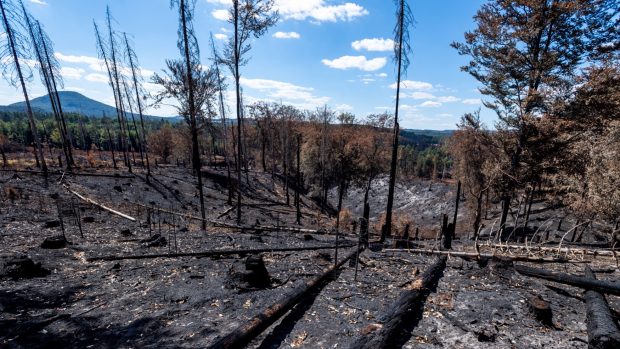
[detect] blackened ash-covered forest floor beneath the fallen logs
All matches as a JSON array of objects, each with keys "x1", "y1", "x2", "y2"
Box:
[{"x1": 0, "y1": 167, "x2": 620, "y2": 348}]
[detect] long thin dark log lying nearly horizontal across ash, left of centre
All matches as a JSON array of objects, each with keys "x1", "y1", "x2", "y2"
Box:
[{"x1": 86, "y1": 244, "x2": 355, "y2": 262}]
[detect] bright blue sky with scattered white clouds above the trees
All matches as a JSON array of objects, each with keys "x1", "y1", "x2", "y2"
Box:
[{"x1": 0, "y1": 0, "x2": 495, "y2": 129}]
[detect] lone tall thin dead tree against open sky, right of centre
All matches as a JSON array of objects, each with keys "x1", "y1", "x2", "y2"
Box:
[{"x1": 381, "y1": 0, "x2": 414, "y2": 241}]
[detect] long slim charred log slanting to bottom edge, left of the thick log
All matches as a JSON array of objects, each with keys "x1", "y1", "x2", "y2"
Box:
[{"x1": 209, "y1": 247, "x2": 357, "y2": 349}]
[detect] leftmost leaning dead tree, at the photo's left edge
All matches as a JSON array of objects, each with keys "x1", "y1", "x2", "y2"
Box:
[{"x1": 0, "y1": 0, "x2": 47, "y2": 173}]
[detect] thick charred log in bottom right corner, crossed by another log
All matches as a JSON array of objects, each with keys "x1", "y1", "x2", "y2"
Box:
[{"x1": 585, "y1": 266, "x2": 620, "y2": 349}]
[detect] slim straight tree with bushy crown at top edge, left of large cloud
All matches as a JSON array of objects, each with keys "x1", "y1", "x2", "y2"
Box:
[{"x1": 222, "y1": 0, "x2": 278, "y2": 223}]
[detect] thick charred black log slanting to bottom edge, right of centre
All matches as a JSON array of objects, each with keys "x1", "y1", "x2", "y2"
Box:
[{"x1": 351, "y1": 256, "x2": 448, "y2": 349}]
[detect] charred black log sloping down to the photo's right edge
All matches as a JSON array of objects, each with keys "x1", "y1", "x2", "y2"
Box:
[{"x1": 515, "y1": 264, "x2": 620, "y2": 296}]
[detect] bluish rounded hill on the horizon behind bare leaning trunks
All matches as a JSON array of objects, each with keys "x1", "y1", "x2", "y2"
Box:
[{"x1": 0, "y1": 91, "x2": 179, "y2": 122}]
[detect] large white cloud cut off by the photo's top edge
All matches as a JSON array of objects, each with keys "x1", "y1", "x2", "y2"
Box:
[{"x1": 275, "y1": 0, "x2": 369, "y2": 22}]
